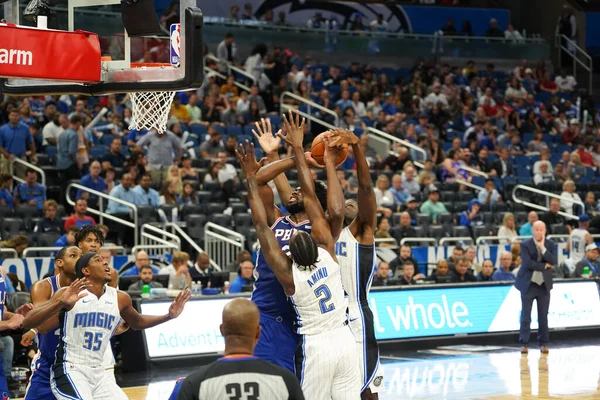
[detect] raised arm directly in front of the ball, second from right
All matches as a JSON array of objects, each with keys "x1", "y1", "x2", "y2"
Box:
[{"x1": 323, "y1": 129, "x2": 346, "y2": 241}]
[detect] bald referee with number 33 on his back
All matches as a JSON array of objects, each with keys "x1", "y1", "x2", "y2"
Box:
[{"x1": 171, "y1": 299, "x2": 304, "y2": 400}]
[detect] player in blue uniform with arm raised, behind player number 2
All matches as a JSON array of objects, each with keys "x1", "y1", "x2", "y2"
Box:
[{"x1": 252, "y1": 112, "x2": 327, "y2": 371}]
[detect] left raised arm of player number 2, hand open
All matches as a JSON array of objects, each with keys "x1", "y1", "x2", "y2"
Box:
[{"x1": 235, "y1": 142, "x2": 295, "y2": 296}]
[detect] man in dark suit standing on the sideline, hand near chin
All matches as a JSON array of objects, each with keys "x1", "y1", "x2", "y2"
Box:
[{"x1": 515, "y1": 221, "x2": 557, "y2": 354}]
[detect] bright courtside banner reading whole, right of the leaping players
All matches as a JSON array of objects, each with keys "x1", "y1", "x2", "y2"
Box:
[{"x1": 369, "y1": 281, "x2": 600, "y2": 340}]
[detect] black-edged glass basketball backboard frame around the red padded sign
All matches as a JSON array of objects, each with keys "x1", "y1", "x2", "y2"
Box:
[{"x1": 0, "y1": 0, "x2": 203, "y2": 95}]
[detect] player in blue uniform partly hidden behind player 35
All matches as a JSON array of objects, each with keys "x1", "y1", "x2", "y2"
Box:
[{"x1": 23, "y1": 246, "x2": 81, "y2": 400}]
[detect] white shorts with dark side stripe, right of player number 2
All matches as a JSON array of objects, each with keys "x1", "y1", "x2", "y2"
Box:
[{"x1": 349, "y1": 305, "x2": 383, "y2": 393}]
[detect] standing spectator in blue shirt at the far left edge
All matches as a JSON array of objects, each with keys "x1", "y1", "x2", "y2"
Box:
[{"x1": 0, "y1": 108, "x2": 37, "y2": 177}]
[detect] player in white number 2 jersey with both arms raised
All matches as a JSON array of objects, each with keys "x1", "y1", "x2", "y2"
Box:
[{"x1": 236, "y1": 111, "x2": 361, "y2": 400}]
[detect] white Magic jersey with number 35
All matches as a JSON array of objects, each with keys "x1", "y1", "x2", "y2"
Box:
[{"x1": 55, "y1": 285, "x2": 121, "y2": 367}]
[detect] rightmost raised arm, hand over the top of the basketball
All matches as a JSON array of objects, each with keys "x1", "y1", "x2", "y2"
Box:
[{"x1": 330, "y1": 130, "x2": 377, "y2": 239}]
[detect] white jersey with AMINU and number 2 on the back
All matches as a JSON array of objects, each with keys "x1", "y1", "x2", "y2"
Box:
[{"x1": 289, "y1": 248, "x2": 348, "y2": 335}]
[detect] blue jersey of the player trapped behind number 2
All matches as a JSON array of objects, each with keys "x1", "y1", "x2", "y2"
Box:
[{"x1": 252, "y1": 215, "x2": 311, "y2": 322}]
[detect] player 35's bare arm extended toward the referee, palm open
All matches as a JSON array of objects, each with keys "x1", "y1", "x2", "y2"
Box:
[{"x1": 118, "y1": 289, "x2": 191, "y2": 330}]
